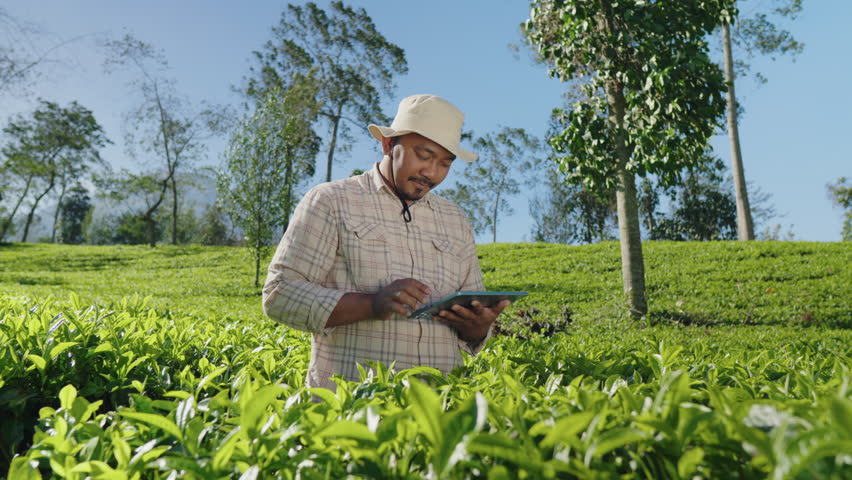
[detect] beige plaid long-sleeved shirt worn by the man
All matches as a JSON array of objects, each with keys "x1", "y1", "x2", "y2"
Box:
[{"x1": 263, "y1": 164, "x2": 485, "y2": 390}]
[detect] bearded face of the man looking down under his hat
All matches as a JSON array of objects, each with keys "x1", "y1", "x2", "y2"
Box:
[{"x1": 382, "y1": 133, "x2": 456, "y2": 201}]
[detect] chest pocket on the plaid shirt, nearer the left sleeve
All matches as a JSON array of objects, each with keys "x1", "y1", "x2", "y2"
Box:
[{"x1": 340, "y1": 218, "x2": 391, "y2": 293}]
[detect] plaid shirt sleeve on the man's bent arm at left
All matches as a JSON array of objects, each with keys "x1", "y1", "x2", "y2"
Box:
[{"x1": 263, "y1": 185, "x2": 345, "y2": 335}]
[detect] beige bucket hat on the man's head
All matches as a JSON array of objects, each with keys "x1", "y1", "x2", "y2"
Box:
[{"x1": 367, "y1": 95, "x2": 479, "y2": 163}]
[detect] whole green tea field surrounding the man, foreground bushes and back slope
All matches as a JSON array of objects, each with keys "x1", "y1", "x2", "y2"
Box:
[{"x1": 0, "y1": 243, "x2": 852, "y2": 479}]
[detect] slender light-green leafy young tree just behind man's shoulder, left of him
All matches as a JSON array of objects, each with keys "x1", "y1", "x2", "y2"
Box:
[{"x1": 218, "y1": 83, "x2": 319, "y2": 286}]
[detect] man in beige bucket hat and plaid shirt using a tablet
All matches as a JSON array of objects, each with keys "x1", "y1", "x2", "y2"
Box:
[{"x1": 263, "y1": 95, "x2": 509, "y2": 390}]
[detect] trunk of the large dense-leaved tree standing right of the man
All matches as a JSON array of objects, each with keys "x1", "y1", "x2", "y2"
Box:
[{"x1": 606, "y1": 82, "x2": 648, "y2": 318}]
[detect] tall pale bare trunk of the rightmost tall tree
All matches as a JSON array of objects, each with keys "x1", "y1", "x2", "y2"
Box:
[{"x1": 722, "y1": 23, "x2": 754, "y2": 240}]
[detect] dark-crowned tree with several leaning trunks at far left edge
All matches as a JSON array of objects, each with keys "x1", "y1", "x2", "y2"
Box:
[{"x1": 0, "y1": 100, "x2": 109, "y2": 242}]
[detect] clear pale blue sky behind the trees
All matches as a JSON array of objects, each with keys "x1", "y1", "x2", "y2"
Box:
[{"x1": 0, "y1": 0, "x2": 852, "y2": 243}]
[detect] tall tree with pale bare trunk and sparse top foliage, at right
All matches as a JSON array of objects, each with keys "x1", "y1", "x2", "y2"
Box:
[{"x1": 721, "y1": 0, "x2": 804, "y2": 240}]
